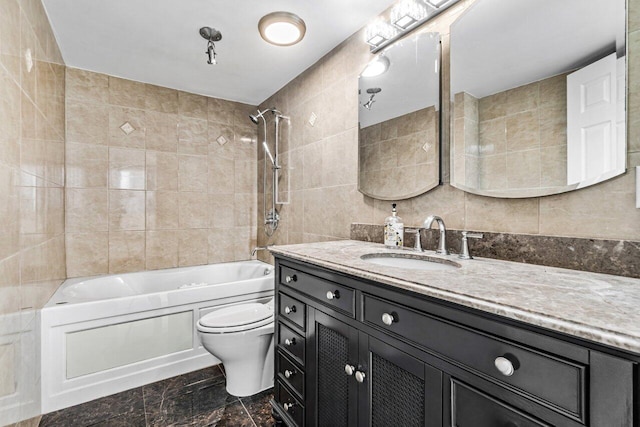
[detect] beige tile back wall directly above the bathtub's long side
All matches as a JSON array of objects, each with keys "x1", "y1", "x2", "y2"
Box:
[{"x1": 66, "y1": 69, "x2": 257, "y2": 277}]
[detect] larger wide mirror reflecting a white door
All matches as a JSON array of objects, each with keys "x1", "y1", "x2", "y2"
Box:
[{"x1": 451, "y1": 0, "x2": 626, "y2": 198}]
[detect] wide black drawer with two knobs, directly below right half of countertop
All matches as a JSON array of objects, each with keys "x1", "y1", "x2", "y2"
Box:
[{"x1": 364, "y1": 295, "x2": 585, "y2": 421}]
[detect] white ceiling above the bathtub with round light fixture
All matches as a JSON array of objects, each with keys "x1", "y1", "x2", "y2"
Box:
[{"x1": 43, "y1": 0, "x2": 394, "y2": 105}]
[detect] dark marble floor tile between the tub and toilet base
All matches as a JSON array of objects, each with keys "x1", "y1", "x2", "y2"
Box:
[{"x1": 142, "y1": 365, "x2": 225, "y2": 402}]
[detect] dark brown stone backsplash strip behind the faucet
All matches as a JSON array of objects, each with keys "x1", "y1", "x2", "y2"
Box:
[{"x1": 351, "y1": 223, "x2": 640, "y2": 278}]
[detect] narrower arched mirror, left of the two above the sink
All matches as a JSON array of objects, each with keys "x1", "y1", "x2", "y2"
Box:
[{"x1": 358, "y1": 32, "x2": 440, "y2": 200}]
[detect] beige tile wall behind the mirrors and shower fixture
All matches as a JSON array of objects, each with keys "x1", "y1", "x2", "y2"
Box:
[{"x1": 258, "y1": 0, "x2": 640, "y2": 256}]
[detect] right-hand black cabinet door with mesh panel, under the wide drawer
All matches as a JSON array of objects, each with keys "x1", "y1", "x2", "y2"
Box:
[{"x1": 358, "y1": 333, "x2": 442, "y2": 427}]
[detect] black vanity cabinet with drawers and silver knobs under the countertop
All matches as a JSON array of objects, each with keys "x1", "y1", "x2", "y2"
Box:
[{"x1": 272, "y1": 256, "x2": 638, "y2": 427}]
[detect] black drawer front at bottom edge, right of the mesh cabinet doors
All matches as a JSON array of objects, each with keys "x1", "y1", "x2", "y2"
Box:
[{"x1": 451, "y1": 380, "x2": 549, "y2": 427}]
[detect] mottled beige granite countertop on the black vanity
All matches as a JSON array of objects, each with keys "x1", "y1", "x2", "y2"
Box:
[{"x1": 269, "y1": 240, "x2": 640, "y2": 354}]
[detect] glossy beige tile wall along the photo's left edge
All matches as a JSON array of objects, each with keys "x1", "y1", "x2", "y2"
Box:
[{"x1": 0, "y1": 0, "x2": 66, "y2": 425}]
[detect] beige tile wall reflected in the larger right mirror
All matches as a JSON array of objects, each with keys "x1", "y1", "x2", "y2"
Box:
[{"x1": 452, "y1": 74, "x2": 567, "y2": 194}]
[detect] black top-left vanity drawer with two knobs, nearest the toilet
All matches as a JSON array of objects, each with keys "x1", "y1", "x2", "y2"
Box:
[{"x1": 280, "y1": 266, "x2": 355, "y2": 317}]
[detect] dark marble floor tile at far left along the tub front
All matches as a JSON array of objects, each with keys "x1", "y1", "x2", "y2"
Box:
[{"x1": 40, "y1": 387, "x2": 144, "y2": 427}]
